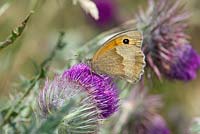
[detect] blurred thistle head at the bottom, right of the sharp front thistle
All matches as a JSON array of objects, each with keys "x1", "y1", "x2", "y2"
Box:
[{"x1": 126, "y1": 88, "x2": 170, "y2": 134}]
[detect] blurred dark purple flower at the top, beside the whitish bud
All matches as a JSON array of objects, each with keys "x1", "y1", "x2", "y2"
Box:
[{"x1": 87, "y1": 0, "x2": 118, "y2": 29}]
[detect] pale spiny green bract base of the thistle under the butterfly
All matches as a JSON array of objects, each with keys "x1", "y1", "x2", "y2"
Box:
[{"x1": 38, "y1": 75, "x2": 99, "y2": 134}]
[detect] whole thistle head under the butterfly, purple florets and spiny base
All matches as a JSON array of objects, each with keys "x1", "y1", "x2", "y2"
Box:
[{"x1": 38, "y1": 64, "x2": 118, "y2": 134}]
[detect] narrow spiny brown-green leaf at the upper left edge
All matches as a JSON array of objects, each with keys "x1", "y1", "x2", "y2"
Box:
[{"x1": 0, "y1": 11, "x2": 33, "y2": 50}]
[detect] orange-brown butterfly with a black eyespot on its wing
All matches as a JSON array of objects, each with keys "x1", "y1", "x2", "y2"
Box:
[{"x1": 90, "y1": 30, "x2": 145, "y2": 83}]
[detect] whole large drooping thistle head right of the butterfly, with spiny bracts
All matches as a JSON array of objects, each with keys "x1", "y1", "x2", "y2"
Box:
[{"x1": 137, "y1": 0, "x2": 200, "y2": 80}]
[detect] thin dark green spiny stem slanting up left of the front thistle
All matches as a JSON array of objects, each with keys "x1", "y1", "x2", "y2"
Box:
[{"x1": 0, "y1": 32, "x2": 66, "y2": 132}]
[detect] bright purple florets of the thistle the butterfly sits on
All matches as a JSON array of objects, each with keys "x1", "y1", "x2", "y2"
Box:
[{"x1": 63, "y1": 64, "x2": 119, "y2": 118}]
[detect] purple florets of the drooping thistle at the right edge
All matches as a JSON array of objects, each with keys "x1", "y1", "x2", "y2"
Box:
[{"x1": 165, "y1": 44, "x2": 200, "y2": 81}]
